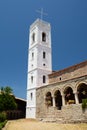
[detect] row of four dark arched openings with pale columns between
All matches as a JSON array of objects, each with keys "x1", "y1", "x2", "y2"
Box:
[{"x1": 45, "y1": 83, "x2": 87, "y2": 110}]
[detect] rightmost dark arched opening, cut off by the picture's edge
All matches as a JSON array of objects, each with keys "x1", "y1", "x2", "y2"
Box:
[{"x1": 77, "y1": 82, "x2": 87, "y2": 103}]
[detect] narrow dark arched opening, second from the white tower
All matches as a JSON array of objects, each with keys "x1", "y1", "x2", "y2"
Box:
[{"x1": 54, "y1": 89, "x2": 62, "y2": 110}]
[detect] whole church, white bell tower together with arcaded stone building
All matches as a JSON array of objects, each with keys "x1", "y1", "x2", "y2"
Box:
[{"x1": 26, "y1": 19, "x2": 87, "y2": 123}]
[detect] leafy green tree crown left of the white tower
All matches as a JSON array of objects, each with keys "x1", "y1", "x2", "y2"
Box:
[{"x1": 0, "y1": 86, "x2": 17, "y2": 111}]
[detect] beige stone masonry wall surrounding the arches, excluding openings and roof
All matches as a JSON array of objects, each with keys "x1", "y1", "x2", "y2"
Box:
[{"x1": 36, "y1": 76, "x2": 87, "y2": 123}]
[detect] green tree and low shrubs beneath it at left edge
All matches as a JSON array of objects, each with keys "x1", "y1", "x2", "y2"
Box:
[{"x1": 0, "y1": 86, "x2": 17, "y2": 130}]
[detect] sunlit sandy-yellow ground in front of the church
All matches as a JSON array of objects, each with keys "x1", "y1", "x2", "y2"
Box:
[{"x1": 4, "y1": 119, "x2": 87, "y2": 130}]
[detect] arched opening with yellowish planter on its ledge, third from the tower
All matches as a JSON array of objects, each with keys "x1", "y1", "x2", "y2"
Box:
[{"x1": 64, "y1": 86, "x2": 75, "y2": 104}]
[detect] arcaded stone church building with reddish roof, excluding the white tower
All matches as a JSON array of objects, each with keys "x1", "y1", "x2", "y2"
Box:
[{"x1": 36, "y1": 61, "x2": 87, "y2": 123}]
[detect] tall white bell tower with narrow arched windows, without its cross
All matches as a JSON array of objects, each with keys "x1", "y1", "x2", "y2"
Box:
[{"x1": 26, "y1": 19, "x2": 52, "y2": 118}]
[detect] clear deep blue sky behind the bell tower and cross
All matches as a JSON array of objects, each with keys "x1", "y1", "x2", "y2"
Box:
[{"x1": 0, "y1": 0, "x2": 87, "y2": 99}]
